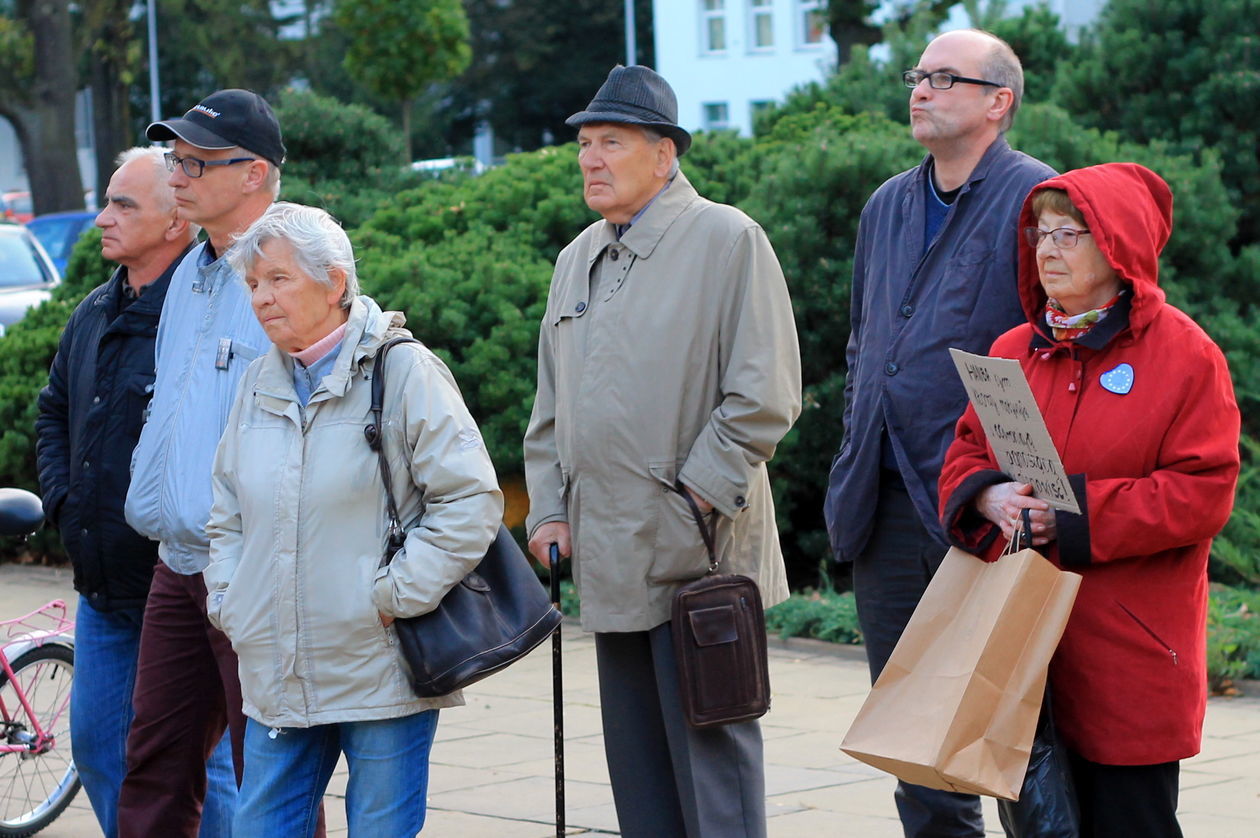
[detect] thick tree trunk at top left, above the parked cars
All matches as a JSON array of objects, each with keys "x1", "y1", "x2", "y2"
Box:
[{"x1": 20, "y1": 0, "x2": 83, "y2": 215}]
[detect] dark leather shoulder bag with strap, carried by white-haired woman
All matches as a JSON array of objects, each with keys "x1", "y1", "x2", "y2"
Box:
[{"x1": 363, "y1": 338, "x2": 562, "y2": 698}]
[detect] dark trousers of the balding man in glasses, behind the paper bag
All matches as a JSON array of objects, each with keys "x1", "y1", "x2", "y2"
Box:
[{"x1": 853, "y1": 473, "x2": 984, "y2": 838}]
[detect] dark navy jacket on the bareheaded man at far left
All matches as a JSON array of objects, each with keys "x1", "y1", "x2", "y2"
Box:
[{"x1": 35, "y1": 251, "x2": 186, "y2": 611}]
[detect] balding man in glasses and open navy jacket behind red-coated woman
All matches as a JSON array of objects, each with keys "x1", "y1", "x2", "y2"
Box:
[{"x1": 825, "y1": 29, "x2": 1055, "y2": 838}]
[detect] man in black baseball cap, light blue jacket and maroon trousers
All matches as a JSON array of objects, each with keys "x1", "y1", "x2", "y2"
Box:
[{"x1": 118, "y1": 89, "x2": 323, "y2": 838}]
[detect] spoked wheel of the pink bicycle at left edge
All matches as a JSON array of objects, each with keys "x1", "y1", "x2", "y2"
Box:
[{"x1": 0, "y1": 645, "x2": 79, "y2": 838}]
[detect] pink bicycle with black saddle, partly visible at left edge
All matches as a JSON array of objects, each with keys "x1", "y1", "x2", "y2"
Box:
[{"x1": 0, "y1": 489, "x2": 79, "y2": 838}]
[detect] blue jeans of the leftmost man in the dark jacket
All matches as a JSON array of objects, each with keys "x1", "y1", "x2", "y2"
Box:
[{"x1": 71, "y1": 596, "x2": 237, "y2": 838}]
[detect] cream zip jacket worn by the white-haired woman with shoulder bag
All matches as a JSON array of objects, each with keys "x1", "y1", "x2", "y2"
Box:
[{"x1": 205, "y1": 296, "x2": 503, "y2": 727}]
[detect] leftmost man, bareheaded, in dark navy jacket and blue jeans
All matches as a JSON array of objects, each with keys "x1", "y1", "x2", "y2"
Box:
[{"x1": 35, "y1": 146, "x2": 236, "y2": 837}]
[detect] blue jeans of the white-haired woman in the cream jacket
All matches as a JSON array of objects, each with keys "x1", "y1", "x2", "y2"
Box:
[{"x1": 232, "y1": 709, "x2": 437, "y2": 838}]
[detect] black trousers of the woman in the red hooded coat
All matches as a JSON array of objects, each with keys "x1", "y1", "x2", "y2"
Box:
[{"x1": 1068, "y1": 751, "x2": 1182, "y2": 838}]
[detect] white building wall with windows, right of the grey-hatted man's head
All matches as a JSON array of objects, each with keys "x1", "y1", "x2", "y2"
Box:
[{"x1": 653, "y1": 0, "x2": 835, "y2": 135}]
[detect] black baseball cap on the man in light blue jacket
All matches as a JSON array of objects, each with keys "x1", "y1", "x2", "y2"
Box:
[{"x1": 145, "y1": 89, "x2": 285, "y2": 166}]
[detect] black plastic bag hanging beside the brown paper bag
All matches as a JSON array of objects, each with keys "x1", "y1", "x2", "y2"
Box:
[{"x1": 998, "y1": 688, "x2": 1081, "y2": 838}]
